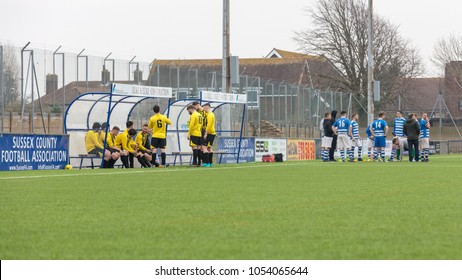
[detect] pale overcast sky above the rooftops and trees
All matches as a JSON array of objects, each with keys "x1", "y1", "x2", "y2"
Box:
[{"x1": 0, "y1": 0, "x2": 462, "y2": 76}]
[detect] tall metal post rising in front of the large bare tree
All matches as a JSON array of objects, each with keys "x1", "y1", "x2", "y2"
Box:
[{"x1": 367, "y1": 0, "x2": 374, "y2": 123}]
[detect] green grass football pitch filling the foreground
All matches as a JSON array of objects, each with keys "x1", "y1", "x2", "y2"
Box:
[{"x1": 0, "y1": 156, "x2": 462, "y2": 259}]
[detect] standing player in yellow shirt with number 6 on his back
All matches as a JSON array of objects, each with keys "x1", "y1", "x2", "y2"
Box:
[{"x1": 148, "y1": 105, "x2": 172, "y2": 167}]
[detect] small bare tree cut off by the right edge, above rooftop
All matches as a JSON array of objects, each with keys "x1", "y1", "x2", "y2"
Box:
[{"x1": 431, "y1": 34, "x2": 462, "y2": 88}]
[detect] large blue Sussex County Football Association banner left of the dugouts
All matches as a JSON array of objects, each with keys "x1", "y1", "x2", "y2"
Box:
[{"x1": 0, "y1": 134, "x2": 69, "y2": 171}]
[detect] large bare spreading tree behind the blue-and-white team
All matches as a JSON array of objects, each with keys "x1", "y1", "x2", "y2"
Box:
[{"x1": 294, "y1": 0, "x2": 423, "y2": 109}]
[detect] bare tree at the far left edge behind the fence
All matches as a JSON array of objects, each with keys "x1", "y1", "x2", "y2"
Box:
[{"x1": 3, "y1": 45, "x2": 21, "y2": 105}]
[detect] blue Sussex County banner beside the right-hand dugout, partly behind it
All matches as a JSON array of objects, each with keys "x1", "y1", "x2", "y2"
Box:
[{"x1": 217, "y1": 137, "x2": 255, "y2": 163}]
